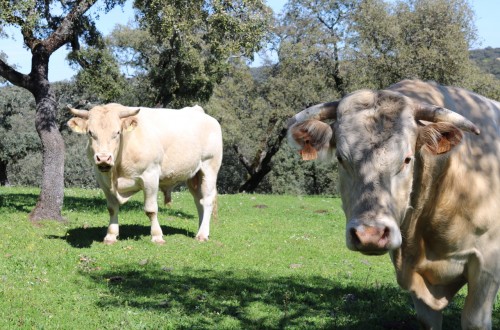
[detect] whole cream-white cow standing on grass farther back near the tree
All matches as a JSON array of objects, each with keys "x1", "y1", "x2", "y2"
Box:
[{"x1": 68, "y1": 103, "x2": 222, "y2": 244}]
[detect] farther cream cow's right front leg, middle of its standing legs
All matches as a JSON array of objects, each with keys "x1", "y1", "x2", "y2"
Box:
[{"x1": 143, "y1": 175, "x2": 165, "y2": 244}]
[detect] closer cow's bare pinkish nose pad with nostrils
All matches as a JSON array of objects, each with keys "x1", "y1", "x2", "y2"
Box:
[{"x1": 348, "y1": 225, "x2": 391, "y2": 254}]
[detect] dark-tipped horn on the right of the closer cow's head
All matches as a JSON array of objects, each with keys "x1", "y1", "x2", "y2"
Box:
[{"x1": 414, "y1": 103, "x2": 480, "y2": 135}]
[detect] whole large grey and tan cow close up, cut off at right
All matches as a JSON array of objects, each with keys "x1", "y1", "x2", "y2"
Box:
[{"x1": 289, "y1": 80, "x2": 500, "y2": 329}]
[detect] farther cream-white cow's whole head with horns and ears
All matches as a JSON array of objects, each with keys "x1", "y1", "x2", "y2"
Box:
[{"x1": 68, "y1": 103, "x2": 140, "y2": 172}]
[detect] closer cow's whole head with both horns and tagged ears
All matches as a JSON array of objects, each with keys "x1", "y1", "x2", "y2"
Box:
[{"x1": 288, "y1": 90, "x2": 479, "y2": 254}]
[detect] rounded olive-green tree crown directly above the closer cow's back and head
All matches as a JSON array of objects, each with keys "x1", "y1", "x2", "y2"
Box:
[{"x1": 354, "y1": 0, "x2": 476, "y2": 88}]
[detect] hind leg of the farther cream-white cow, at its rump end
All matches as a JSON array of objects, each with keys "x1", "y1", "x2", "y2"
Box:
[{"x1": 188, "y1": 169, "x2": 217, "y2": 242}]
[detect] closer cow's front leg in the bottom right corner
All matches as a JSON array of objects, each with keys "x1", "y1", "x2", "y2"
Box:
[{"x1": 462, "y1": 258, "x2": 500, "y2": 329}]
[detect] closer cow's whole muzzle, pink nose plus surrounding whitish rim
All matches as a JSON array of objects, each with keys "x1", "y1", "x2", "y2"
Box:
[{"x1": 346, "y1": 219, "x2": 401, "y2": 255}]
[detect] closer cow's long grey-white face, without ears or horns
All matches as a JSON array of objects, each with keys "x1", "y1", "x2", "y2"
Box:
[{"x1": 334, "y1": 91, "x2": 418, "y2": 254}]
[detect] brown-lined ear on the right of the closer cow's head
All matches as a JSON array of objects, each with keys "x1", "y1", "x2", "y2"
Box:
[{"x1": 417, "y1": 122, "x2": 463, "y2": 155}]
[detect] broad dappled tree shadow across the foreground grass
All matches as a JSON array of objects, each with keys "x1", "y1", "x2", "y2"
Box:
[{"x1": 86, "y1": 264, "x2": 440, "y2": 329}]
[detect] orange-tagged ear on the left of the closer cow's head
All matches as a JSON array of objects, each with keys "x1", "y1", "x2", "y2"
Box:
[{"x1": 288, "y1": 119, "x2": 333, "y2": 160}]
